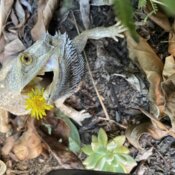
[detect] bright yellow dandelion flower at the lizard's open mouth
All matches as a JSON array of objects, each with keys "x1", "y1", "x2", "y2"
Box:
[{"x1": 25, "y1": 88, "x2": 53, "y2": 120}]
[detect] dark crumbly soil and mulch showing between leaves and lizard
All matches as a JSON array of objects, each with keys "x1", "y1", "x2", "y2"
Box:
[{"x1": 0, "y1": 1, "x2": 175, "y2": 175}]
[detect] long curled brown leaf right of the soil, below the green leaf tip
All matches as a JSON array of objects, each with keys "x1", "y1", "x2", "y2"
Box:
[{"x1": 125, "y1": 32, "x2": 164, "y2": 113}]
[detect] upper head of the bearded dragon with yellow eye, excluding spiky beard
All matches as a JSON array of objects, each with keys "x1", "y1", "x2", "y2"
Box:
[{"x1": 3, "y1": 36, "x2": 54, "y2": 93}]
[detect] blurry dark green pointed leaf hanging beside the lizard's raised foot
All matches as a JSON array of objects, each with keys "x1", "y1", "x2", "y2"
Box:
[{"x1": 114, "y1": 0, "x2": 139, "y2": 42}]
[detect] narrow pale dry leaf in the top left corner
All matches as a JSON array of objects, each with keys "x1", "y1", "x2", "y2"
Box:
[{"x1": 0, "y1": 0, "x2": 14, "y2": 36}]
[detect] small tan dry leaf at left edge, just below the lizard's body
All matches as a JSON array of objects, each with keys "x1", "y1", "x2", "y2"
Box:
[{"x1": 0, "y1": 109, "x2": 11, "y2": 133}]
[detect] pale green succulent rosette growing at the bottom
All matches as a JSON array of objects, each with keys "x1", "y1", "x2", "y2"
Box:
[{"x1": 82, "y1": 129, "x2": 136, "y2": 173}]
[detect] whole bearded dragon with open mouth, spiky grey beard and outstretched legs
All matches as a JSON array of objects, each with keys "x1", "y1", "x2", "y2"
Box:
[{"x1": 0, "y1": 24, "x2": 125, "y2": 123}]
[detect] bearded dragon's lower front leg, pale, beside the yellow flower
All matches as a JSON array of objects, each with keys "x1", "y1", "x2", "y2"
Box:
[{"x1": 55, "y1": 94, "x2": 91, "y2": 125}]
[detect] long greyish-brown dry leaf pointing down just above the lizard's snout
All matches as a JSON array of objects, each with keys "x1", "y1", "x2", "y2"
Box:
[{"x1": 31, "y1": 0, "x2": 59, "y2": 41}]
